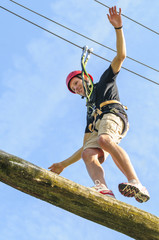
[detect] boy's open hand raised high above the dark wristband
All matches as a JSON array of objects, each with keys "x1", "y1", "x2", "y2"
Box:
[{"x1": 107, "y1": 6, "x2": 122, "y2": 28}]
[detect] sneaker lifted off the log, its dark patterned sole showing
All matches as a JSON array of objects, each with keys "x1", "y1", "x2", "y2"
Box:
[{"x1": 118, "y1": 183, "x2": 150, "y2": 203}]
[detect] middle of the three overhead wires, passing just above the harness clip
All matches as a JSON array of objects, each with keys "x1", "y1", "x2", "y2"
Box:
[{"x1": 9, "y1": 0, "x2": 159, "y2": 72}]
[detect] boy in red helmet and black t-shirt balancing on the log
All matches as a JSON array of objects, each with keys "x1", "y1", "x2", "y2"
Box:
[{"x1": 49, "y1": 7, "x2": 150, "y2": 202}]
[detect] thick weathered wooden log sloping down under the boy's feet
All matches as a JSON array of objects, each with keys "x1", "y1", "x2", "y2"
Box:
[{"x1": 0, "y1": 151, "x2": 159, "y2": 240}]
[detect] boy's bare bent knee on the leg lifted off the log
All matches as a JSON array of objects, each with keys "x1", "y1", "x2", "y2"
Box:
[{"x1": 98, "y1": 134, "x2": 114, "y2": 152}]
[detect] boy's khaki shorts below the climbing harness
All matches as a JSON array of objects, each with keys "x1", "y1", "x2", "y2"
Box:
[{"x1": 83, "y1": 113, "x2": 129, "y2": 157}]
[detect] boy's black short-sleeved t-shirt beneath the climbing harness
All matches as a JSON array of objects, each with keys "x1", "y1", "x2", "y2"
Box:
[{"x1": 85, "y1": 65, "x2": 126, "y2": 133}]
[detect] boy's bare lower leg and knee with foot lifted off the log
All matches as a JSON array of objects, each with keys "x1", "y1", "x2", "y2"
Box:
[{"x1": 98, "y1": 134, "x2": 139, "y2": 182}]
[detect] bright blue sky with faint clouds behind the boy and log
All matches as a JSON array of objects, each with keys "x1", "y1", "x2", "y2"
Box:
[{"x1": 0, "y1": 0, "x2": 159, "y2": 240}]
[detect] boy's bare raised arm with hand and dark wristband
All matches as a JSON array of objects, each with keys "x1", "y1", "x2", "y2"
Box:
[{"x1": 107, "y1": 6, "x2": 126, "y2": 73}]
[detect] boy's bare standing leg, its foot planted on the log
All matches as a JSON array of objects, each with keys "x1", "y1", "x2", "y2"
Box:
[{"x1": 82, "y1": 148, "x2": 107, "y2": 187}]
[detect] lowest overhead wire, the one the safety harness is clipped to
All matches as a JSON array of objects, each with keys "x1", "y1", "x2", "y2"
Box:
[{"x1": 0, "y1": 6, "x2": 159, "y2": 85}]
